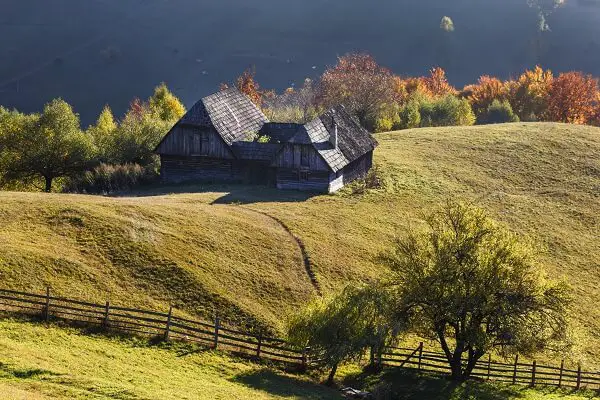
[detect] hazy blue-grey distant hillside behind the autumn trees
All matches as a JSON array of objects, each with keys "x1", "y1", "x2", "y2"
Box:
[{"x1": 0, "y1": 0, "x2": 600, "y2": 125}]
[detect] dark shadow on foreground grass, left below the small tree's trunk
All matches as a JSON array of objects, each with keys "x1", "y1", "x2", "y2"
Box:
[{"x1": 232, "y1": 369, "x2": 342, "y2": 400}]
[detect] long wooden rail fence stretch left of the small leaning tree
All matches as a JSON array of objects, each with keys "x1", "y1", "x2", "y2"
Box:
[{"x1": 0, "y1": 289, "x2": 308, "y2": 370}]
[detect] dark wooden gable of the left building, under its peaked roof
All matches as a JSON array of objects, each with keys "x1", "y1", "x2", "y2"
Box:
[{"x1": 157, "y1": 124, "x2": 234, "y2": 159}]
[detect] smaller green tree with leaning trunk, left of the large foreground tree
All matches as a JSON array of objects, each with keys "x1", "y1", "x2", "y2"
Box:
[{"x1": 288, "y1": 285, "x2": 398, "y2": 384}]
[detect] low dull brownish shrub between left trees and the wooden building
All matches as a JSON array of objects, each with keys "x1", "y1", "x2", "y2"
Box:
[{"x1": 63, "y1": 164, "x2": 158, "y2": 194}]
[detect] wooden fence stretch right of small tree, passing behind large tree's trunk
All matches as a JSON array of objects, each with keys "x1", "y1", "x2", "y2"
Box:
[{"x1": 381, "y1": 343, "x2": 600, "y2": 390}]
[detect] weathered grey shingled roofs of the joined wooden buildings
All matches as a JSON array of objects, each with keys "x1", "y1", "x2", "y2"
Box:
[{"x1": 157, "y1": 88, "x2": 377, "y2": 172}]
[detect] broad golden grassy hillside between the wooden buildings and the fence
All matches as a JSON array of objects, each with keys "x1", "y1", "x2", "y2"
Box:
[{"x1": 0, "y1": 123, "x2": 600, "y2": 363}]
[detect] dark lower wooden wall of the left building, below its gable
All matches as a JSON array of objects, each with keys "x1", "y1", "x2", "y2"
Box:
[{"x1": 160, "y1": 155, "x2": 244, "y2": 183}]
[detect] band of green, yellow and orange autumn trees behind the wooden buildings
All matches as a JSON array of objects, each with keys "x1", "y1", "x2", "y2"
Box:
[{"x1": 0, "y1": 51, "x2": 600, "y2": 193}]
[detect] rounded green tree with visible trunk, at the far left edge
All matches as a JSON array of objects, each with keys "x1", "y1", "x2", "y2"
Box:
[{"x1": 1, "y1": 99, "x2": 95, "y2": 192}]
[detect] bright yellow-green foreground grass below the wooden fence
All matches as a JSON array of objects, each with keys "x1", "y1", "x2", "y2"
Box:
[{"x1": 0, "y1": 319, "x2": 597, "y2": 400}]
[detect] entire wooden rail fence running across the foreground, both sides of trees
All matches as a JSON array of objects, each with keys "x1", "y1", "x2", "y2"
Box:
[{"x1": 0, "y1": 289, "x2": 600, "y2": 390}]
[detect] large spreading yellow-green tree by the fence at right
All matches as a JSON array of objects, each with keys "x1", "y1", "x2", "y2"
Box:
[{"x1": 387, "y1": 203, "x2": 570, "y2": 380}]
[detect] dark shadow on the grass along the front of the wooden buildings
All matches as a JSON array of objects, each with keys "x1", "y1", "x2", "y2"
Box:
[{"x1": 111, "y1": 183, "x2": 318, "y2": 204}]
